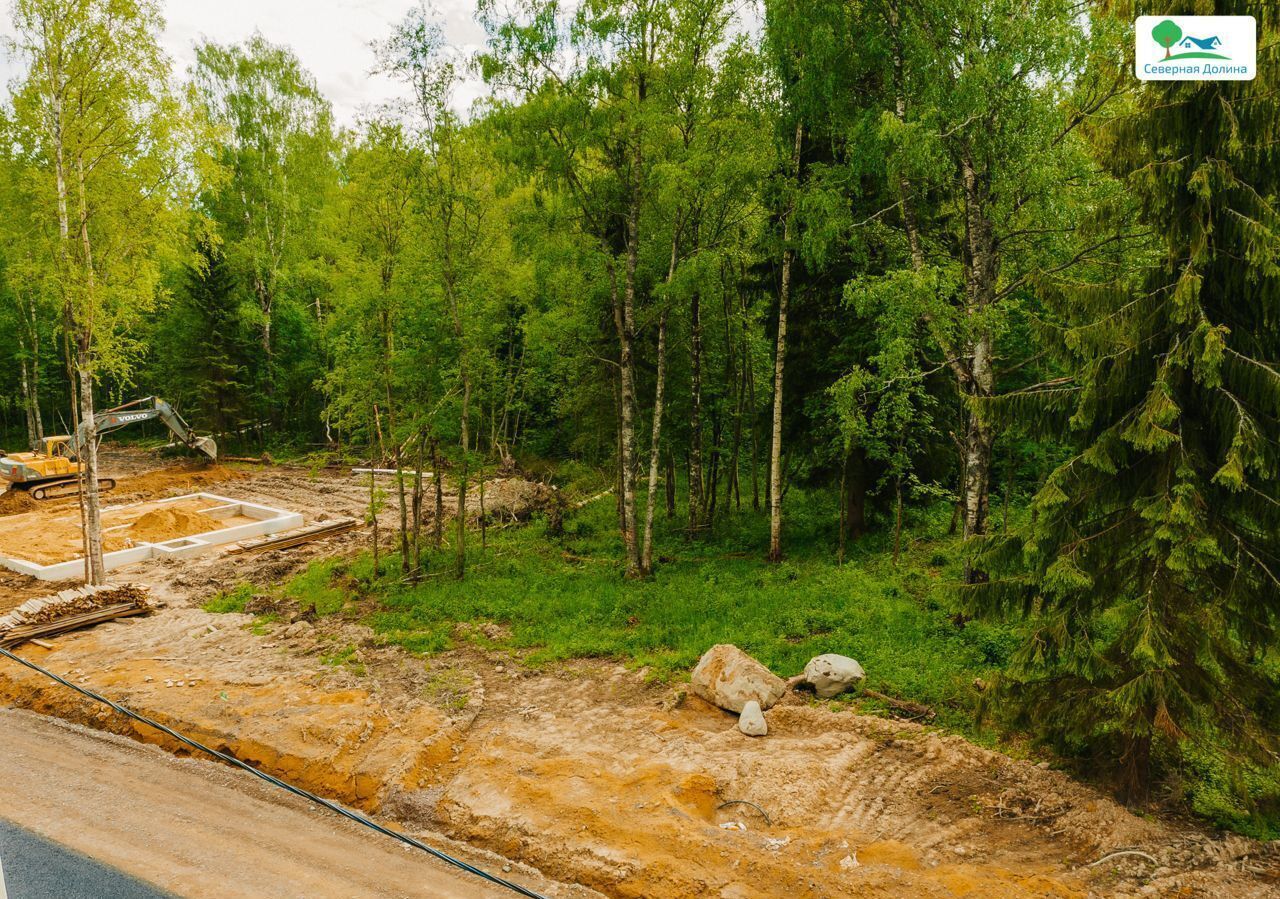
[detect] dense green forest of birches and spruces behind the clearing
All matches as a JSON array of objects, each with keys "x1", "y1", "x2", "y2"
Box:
[{"x1": 0, "y1": 0, "x2": 1280, "y2": 836}]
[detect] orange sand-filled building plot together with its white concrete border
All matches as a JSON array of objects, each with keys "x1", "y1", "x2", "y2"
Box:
[{"x1": 0, "y1": 493, "x2": 302, "y2": 580}]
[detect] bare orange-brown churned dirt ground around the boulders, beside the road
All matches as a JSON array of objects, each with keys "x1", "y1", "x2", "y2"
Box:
[{"x1": 0, "y1": 453, "x2": 1280, "y2": 899}]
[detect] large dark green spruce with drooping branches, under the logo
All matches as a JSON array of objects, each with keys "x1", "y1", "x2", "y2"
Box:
[{"x1": 963, "y1": 3, "x2": 1280, "y2": 797}]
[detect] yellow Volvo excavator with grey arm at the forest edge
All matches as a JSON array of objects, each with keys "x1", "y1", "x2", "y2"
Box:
[{"x1": 0, "y1": 397, "x2": 218, "y2": 499}]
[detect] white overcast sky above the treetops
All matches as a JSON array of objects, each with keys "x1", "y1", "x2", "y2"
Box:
[{"x1": 0, "y1": 0, "x2": 485, "y2": 124}]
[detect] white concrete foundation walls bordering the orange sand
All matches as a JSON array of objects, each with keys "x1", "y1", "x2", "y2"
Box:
[{"x1": 0, "y1": 493, "x2": 302, "y2": 580}]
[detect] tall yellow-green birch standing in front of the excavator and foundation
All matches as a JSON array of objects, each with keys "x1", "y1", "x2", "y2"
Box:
[{"x1": 13, "y1": 0, "x2": 183, "y2": 584}]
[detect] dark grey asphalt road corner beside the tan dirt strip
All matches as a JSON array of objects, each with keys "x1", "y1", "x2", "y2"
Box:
[{"x1": 0, "y1": 818, "x2": 172, "y2": 899}]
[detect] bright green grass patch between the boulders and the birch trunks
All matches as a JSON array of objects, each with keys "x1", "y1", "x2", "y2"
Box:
[{"x1": 340, "y1": 489, "x2": 1016, "y2": 735}]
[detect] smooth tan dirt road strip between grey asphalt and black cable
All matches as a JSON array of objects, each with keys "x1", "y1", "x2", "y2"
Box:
[{"x1": 0, "y1": 709, "x2": 573, "y2": 899}]
